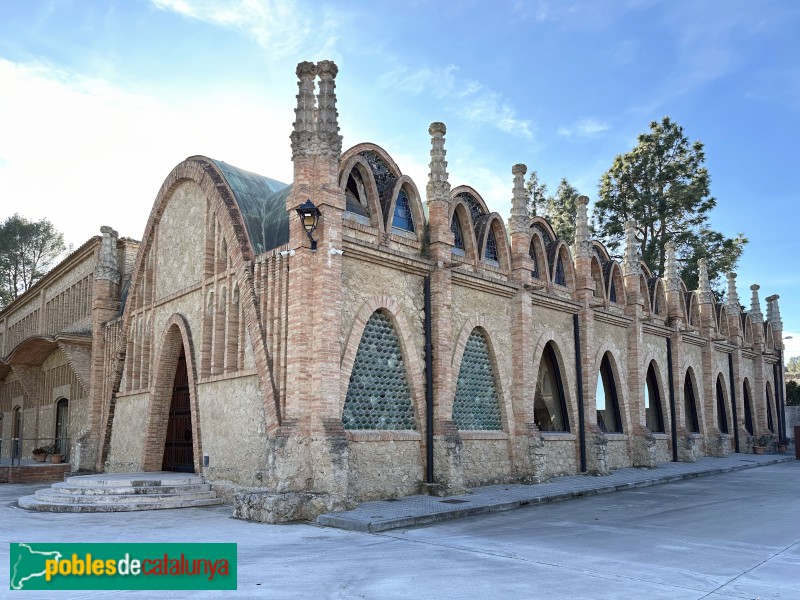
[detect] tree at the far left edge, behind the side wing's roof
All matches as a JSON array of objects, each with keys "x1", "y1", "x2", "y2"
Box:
[{"x1": 0, "y1": 214, "x2": 66, "y2": 308}]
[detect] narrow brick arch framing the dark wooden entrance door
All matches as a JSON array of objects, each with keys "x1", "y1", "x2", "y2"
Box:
[{"x1": 142, "y1": 313, "x2": 203, "y2": 473}]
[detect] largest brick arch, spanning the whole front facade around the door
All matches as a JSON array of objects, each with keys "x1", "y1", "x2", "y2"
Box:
[{"x1": 113, "y1": 156, "x2": 281, "y2": 433}]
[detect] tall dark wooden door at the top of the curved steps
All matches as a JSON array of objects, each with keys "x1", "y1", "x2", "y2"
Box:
[{"x1": 161, "y1": 345, "x2": 194, "y2": 473}]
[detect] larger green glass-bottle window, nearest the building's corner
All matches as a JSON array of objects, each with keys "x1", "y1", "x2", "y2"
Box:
[{"x1": 342, "y1": 311, "x2": 416, "y2": 429}]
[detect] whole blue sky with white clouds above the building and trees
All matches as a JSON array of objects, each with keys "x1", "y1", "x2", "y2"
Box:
[{"x1": 0, "y1": 0, "x2": 800, "y2": 356}]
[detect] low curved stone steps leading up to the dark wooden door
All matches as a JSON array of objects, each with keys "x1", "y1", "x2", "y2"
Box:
[{"x1": 17, "y1": 471, "x2": 222, "y2": 512}]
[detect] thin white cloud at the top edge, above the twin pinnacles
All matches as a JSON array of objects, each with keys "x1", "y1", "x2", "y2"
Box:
[{"x1": 150, "y1": 0, "x2": 338, "y2": 58}]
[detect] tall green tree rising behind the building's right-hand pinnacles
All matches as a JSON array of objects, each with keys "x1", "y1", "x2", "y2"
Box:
[{"x1": 594, "y1": 117, "x2": 747, "y2": 290}]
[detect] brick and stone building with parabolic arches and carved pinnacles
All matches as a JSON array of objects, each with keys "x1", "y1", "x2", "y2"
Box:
[{"x1": 0, "y1": 61, "x2": 784, "y2": 521}]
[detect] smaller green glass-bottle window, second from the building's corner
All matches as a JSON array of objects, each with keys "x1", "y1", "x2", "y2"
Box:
[{"x1": 453, "y1": 329, "x2": 503, "y2": 430}]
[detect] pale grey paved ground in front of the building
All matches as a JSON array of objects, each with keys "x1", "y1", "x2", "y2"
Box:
[{"x1": 0, "y1": 461, "x2": 800, "y2": 600}]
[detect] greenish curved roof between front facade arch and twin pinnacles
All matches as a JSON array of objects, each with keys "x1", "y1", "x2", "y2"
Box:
[{"x1": 212, "y1": 159, "x2": 292, "y2": 254}]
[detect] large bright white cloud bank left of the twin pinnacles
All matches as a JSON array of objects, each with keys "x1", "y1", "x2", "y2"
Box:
[{"x1": 0, "y1": 59, "x2": 293, "y2": 245}]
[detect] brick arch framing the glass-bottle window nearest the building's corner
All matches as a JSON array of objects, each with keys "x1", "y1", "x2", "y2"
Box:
[{"x1": 337, "y1": 296, "x2": 425, "y2": 432}]
